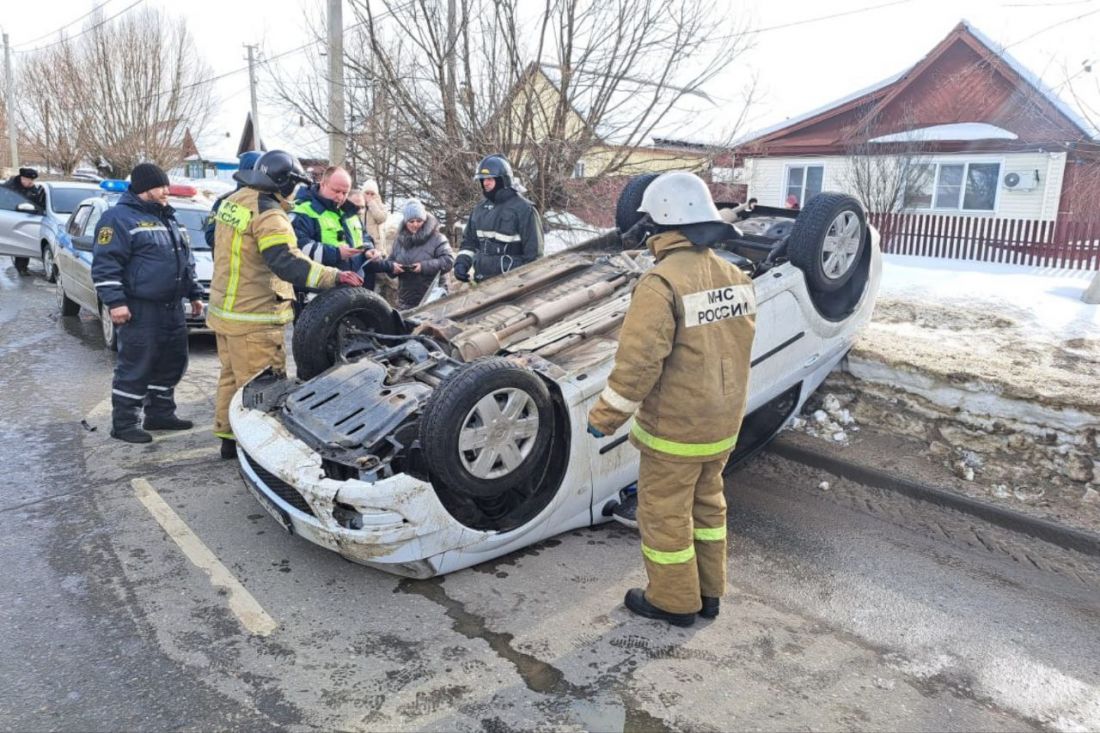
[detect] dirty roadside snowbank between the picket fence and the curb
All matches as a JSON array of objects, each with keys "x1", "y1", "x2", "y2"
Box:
[{"x1": 792, "y1": 255, "x2": 1100, "y2": 530}]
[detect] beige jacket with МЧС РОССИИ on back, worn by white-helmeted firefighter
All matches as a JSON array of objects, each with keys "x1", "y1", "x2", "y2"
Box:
[{"x1": 589, "y1": 231, "x2": 756, "y2": 462}]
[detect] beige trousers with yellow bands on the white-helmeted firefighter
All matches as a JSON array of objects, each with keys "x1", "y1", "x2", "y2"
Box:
[{"x1": 638, "y1": 451, "x2": 729, "y2": 613}]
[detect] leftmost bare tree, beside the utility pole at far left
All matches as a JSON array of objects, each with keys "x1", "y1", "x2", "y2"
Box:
[{"x1": 18, "y1": 41, "x2": 84, "y2": 174}]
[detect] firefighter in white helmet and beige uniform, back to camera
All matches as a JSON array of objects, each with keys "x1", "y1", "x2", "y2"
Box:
[{"x1": 589, "y1": 172, "x2": 756, "y2": 626}]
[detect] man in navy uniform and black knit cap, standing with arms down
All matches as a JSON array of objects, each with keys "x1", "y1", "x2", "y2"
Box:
[{"x1": 91, "y1": 163, "x2": 202, "y2": 442}]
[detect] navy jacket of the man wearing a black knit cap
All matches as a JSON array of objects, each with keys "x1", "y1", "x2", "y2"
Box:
[{"x1": 91, "y1": 190, "x2": 202, "y2": 307}]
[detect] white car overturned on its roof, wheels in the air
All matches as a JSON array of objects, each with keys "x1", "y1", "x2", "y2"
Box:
[{"x1": 230, "y1": 176, "x2": 881, "y2": 578}]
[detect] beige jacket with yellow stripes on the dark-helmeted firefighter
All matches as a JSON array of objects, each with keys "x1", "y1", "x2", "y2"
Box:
[{"x1": 207, "y1": 188, "x2": 339, "y2": 336}]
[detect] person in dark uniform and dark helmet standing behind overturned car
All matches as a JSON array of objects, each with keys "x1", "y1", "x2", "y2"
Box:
[{"x1": 454, "y1": 155, "x2": 542, "y2": 283}]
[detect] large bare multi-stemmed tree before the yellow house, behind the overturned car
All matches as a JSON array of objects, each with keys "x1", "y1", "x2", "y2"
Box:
[{"x1": 265, "y1": 0, "x2": 748, "y2": 221}]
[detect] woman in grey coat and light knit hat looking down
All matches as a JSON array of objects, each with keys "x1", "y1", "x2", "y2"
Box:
[{"x1": 389, "y1": 200, "x2": 454, "y2": 310}]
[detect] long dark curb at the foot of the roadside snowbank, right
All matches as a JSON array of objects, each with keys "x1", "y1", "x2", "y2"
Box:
[{"x1": 767, "y1": 438, "x2": 1100, "y2": 557}]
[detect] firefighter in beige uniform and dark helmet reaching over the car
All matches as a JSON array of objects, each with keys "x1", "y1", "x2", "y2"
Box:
[{"x1": 207, "y1": 150, "x2": 363, "y2": 458}]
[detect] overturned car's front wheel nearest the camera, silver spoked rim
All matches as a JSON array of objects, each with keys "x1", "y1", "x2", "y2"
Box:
[{"x1": 419, "y1": 357, "x2": 554, "y2": 500}]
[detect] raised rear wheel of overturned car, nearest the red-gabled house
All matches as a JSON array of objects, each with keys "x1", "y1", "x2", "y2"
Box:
[{"x1": 787, "y1": 193, "x2": 867, "y2": 294}]
